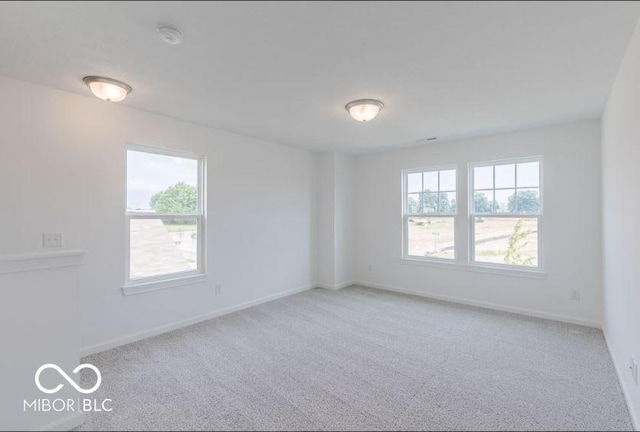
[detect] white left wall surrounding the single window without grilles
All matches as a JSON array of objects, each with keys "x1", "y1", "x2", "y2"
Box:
[{"x1": 0, "y1": 78, "x2": 316, "y2": 354}]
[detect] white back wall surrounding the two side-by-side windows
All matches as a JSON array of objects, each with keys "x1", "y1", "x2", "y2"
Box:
[{"x1": 356, "y1": 120, "x2": 602, "y2": 326}]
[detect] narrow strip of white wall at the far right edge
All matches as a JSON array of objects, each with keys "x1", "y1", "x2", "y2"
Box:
[{"x1": 602, "y1": 16, "x2": 640, "y2": 428}]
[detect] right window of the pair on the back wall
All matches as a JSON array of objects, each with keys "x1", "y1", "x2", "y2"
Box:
[{"x1": 469, "y1": 158, "x2": 542, "y2": 269}]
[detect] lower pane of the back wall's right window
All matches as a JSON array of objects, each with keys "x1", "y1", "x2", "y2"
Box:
[{"x1": 474, "y1": 216, "x2": 538, "y2": 267}]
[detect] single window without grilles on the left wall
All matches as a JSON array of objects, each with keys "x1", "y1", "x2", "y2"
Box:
[{"x1": 125, "y1": 145, "x2": 204, "y2": 292}]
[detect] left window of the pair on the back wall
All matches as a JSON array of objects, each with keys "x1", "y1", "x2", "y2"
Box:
[{"x1": 403, "y1": 167, "x2": 457, "y2": 260}]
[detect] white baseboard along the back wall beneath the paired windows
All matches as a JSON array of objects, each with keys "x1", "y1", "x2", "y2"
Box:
[{"x1": 354, "y1": 281, "x2": 602, "y2": 329}]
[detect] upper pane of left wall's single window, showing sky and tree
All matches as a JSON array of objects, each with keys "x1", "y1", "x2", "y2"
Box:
[{"x1": 127, "y1": 150, "x2": 198, "y2": 213}]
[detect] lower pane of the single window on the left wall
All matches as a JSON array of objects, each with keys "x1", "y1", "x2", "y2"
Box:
[{"x1": 129, "y1": 219, "x2": 198, "y2": 279}]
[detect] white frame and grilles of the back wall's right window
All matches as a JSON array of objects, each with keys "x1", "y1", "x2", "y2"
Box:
[{"x1": 467, "y1": 156, "x2": 544, "y2": 273}]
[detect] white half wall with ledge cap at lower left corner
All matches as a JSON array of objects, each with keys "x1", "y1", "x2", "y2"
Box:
[{"x1": 0, "y1": 251, "x2": 84, "y2": 430}]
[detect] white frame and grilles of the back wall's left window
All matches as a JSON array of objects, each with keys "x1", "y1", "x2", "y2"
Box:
[{"x1": 402, "y1": 165, "x2": 460, "y2": 265}]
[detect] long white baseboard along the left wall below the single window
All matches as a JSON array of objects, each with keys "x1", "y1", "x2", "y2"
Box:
[{"x1": 80, "y1": 284, "x2": 317, "y2": 358}]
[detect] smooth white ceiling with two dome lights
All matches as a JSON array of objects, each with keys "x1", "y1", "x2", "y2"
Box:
[{"x1": 0, "y1": 2, "x2": 640, "y2": 153}]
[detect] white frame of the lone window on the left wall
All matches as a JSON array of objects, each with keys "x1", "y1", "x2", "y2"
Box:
[{"x1": 123, "y1": 144, "x2": 207, "y2": 295}]
